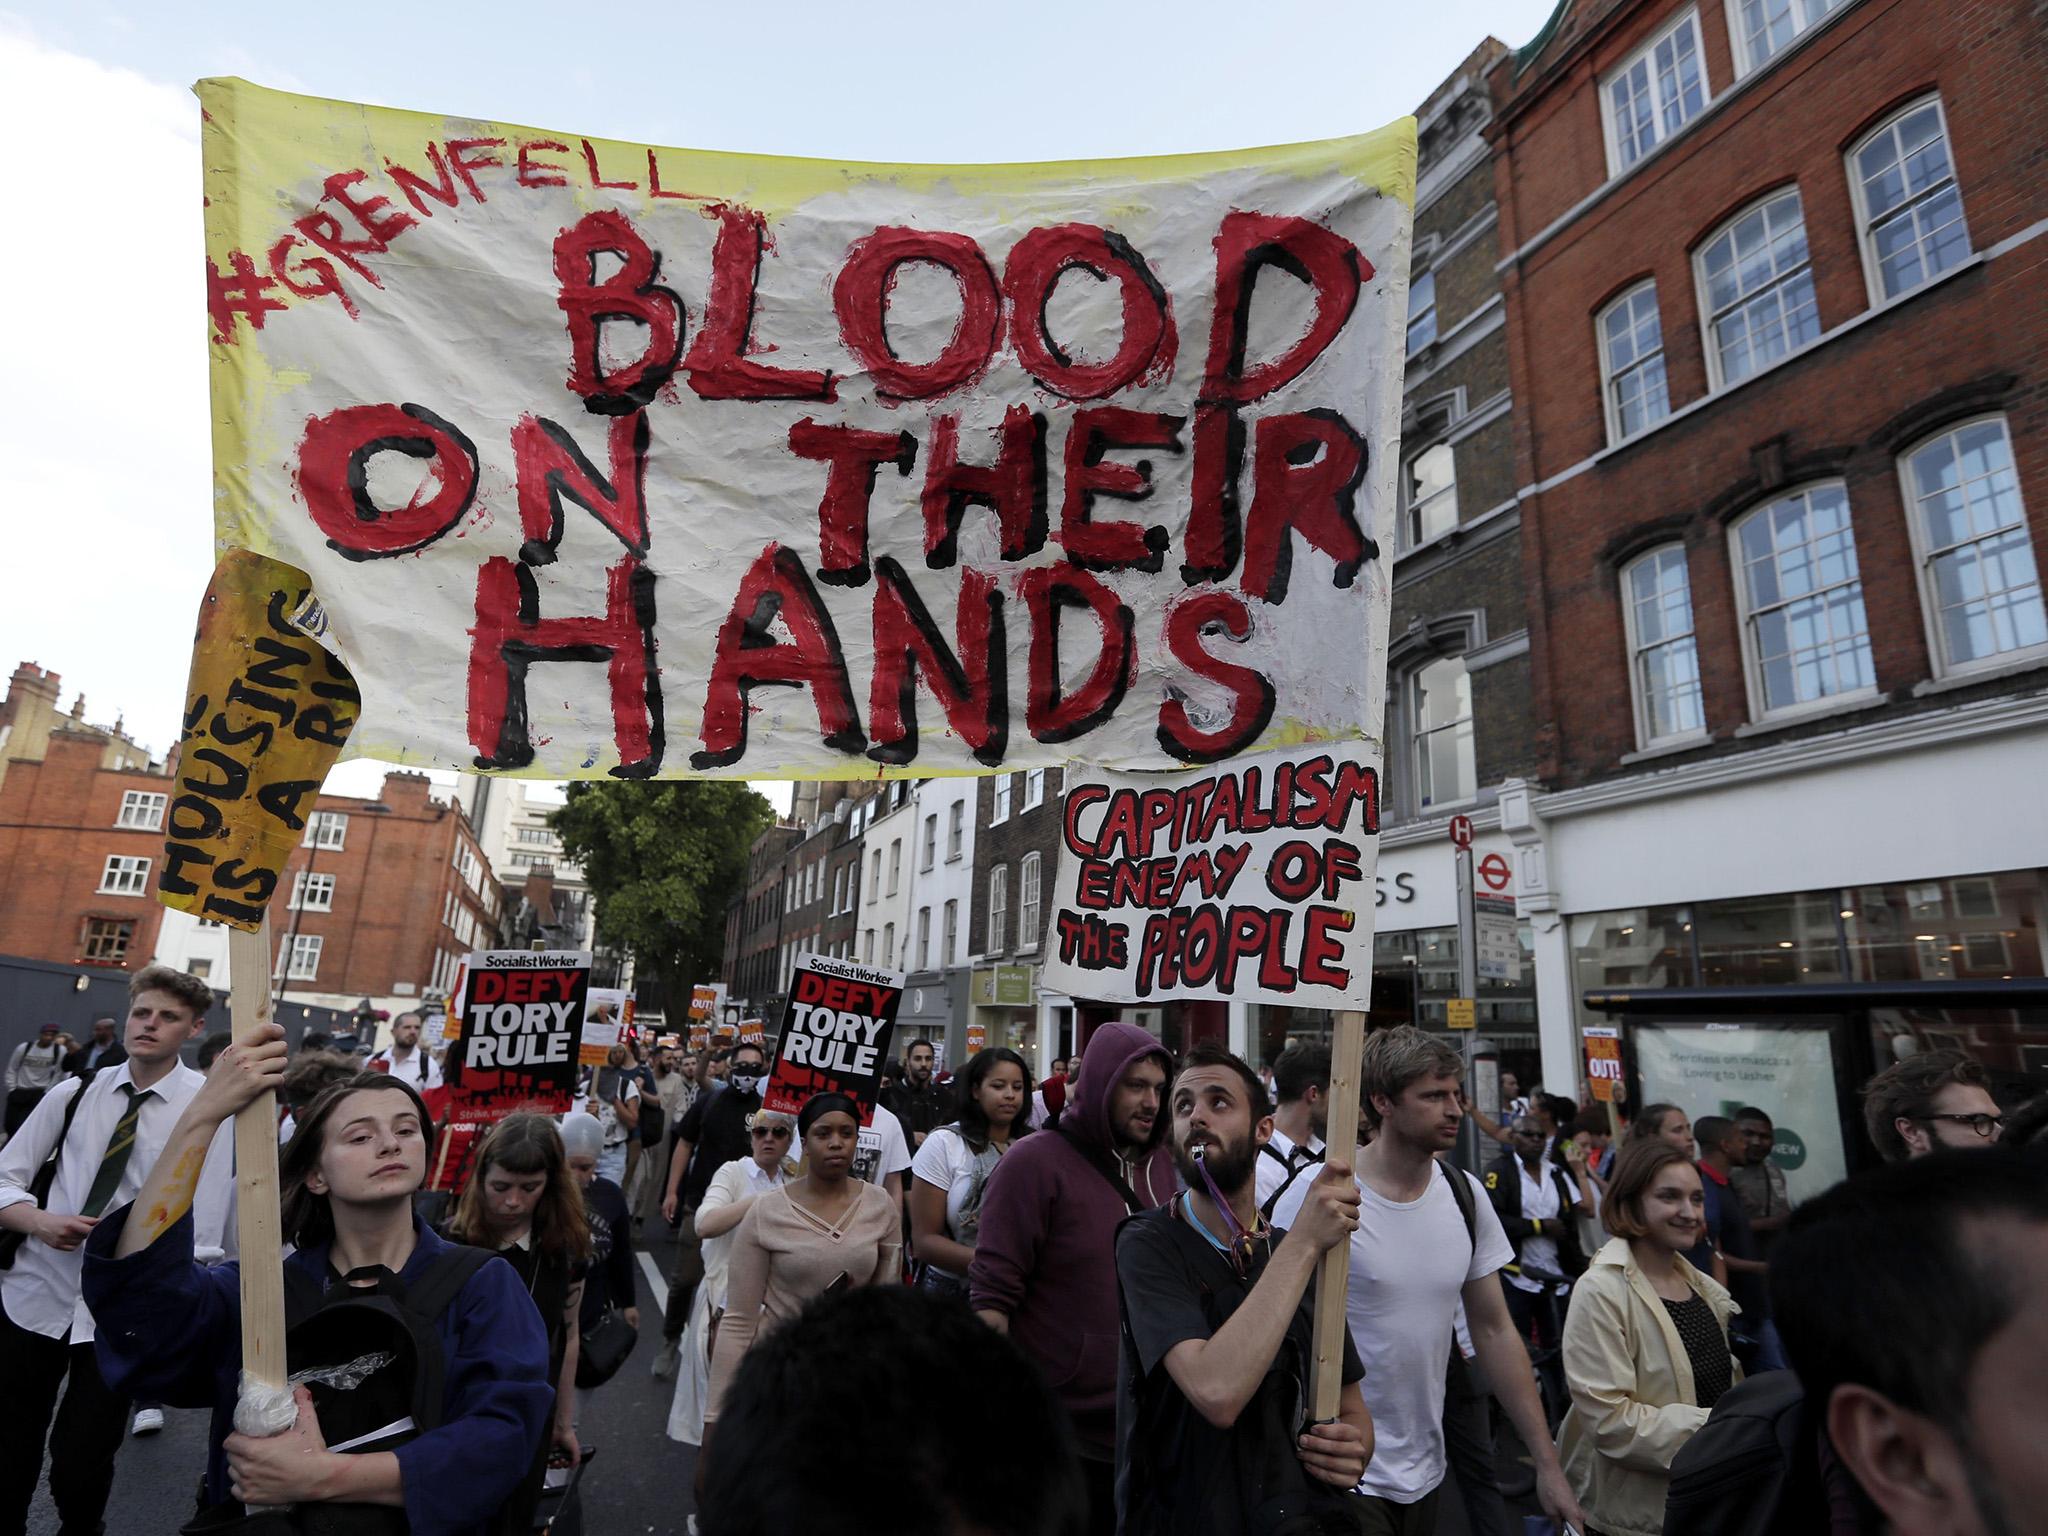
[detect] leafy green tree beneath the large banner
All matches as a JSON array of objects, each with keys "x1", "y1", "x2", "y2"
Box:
[{"x1": 551, "y1": 778, "x2": 774, "y2": 997}]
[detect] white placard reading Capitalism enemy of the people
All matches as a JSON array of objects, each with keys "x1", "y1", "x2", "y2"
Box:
[{"x1": 1040, "y1": 743, "x2": 1380, "y2": 1008}]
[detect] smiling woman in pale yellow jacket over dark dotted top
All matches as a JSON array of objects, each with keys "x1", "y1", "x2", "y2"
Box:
[{"x1": 1556, "y1": 1141, "x2": 1737, "y2": 1536}]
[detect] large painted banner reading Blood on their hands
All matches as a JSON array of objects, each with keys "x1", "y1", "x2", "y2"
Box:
[{"x1": 199, "y1": 80, "x2": 1415, "y2": 778}]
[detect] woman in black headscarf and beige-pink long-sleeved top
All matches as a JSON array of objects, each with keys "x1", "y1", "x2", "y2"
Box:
[{"x1": 698, "y1": 1094, "x2": 903, "y2": 1448}]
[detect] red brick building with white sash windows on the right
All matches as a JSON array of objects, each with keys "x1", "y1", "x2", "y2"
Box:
[{"x1": 1491, "y1": 0, "x2": 2048, "y2": 1151}]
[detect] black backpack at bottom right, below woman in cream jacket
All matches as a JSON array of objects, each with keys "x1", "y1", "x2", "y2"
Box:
[{"x1": 1665, "y1": 1370, "x2": 1827, "y2": 1536}]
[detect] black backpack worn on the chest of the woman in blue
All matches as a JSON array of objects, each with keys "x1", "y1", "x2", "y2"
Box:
[{"x1": 184, "y1": 1245, "x2": 498, "y2": 1536}]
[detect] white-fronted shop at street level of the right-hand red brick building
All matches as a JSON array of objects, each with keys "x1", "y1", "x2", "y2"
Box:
[{"x1": 1501, "y1": 700, "x2": 2048, "y2": 1163}]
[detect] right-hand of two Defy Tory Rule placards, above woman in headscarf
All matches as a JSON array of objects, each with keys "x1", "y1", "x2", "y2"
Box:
[{"x1": 762, "y1": 954, "x2": 903, "y2": 1124}]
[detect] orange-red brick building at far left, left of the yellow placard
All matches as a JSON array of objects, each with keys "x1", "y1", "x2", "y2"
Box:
[{"x1": 0, "y1": 716, "x2": 170, "y2": 971}]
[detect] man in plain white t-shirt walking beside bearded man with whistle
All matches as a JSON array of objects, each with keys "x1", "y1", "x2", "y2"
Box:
[{"x1": 1274, "y1": 1024, "x2": 1585, "y2": 1536}]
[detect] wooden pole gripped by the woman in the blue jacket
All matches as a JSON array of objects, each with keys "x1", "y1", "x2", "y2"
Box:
[{"x1": 227, "y1": 915, "x2": 285, "y2": 1389}]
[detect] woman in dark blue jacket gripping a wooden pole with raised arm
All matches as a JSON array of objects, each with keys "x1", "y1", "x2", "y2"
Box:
[{"x1": 84, "y1": 1024, "x2": 551, "y2": 1536}]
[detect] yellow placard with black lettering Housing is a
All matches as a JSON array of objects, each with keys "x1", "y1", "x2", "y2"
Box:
[{"x1": 158, "y1": 549, "x2": 362, "y2": 932}]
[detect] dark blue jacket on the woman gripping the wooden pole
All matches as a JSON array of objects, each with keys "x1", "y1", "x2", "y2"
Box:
[{"x1": 84, "y1": 1206, "x2": 555, "y2": 1536}]
